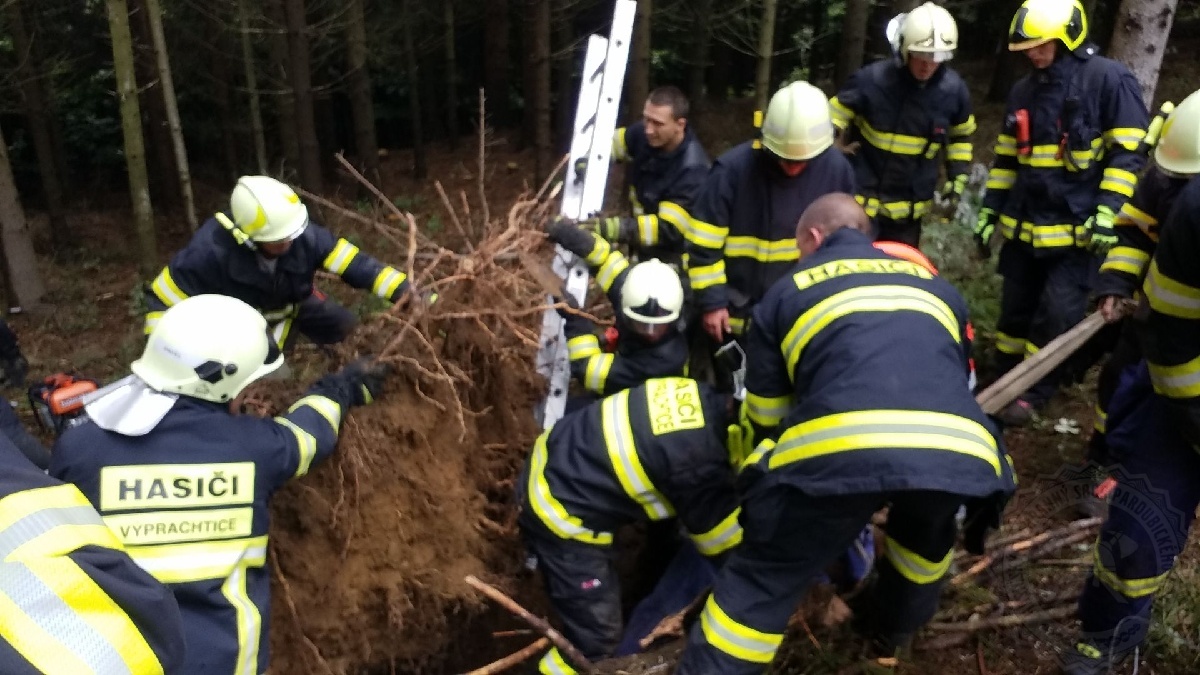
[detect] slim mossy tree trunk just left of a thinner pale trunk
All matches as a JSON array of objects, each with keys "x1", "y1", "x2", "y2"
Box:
[{"x1": 106, "y1": 0, "x2": 158, "y2": 279}]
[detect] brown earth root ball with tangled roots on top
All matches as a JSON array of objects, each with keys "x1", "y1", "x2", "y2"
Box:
[{"x1": 262, "y1": 201, "x2": 559, "y2": 675}]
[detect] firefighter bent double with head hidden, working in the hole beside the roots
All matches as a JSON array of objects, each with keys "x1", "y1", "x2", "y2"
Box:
[{"x1": 517, "y1": 377, "x2": 742, "y2": 674}]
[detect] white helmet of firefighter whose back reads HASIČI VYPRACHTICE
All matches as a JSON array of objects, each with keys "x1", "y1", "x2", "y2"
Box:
[{"x1": 130, "y1": 295, "x2": 283, "y2": 402}]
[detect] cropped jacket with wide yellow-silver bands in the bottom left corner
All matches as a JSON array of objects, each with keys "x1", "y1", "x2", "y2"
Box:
[{"x1": 0, "y1": 429, "x2": 184, "y2": 675}]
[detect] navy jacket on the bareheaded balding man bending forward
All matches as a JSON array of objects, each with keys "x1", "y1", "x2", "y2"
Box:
[{"x1": 743, "y1": 229, "x2": 1014, "y2": 497}]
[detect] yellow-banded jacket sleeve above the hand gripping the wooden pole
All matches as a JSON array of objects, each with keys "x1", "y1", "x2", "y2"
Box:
[{"x1": 1096, "y1": 165, "x2": 1188, "y2": 298}]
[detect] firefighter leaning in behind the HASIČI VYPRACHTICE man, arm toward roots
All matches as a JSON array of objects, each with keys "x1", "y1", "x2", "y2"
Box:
[{"x1": 145, "y1": 175, "x2": 420, "y2": 348}]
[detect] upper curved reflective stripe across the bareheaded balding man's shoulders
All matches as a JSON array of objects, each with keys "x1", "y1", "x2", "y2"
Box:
[{"x1": 781, "y1": 286, "x2": 962, "y2": 378}]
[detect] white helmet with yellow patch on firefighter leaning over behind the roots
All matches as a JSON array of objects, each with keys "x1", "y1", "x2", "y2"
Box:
[{"x1": 229, "y1": 175, "x2": 308, "y2": 243}]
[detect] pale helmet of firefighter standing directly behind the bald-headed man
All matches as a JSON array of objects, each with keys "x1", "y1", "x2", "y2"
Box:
[{"x1": 762, "y1": 82, "x2": 833, "y2": 162}]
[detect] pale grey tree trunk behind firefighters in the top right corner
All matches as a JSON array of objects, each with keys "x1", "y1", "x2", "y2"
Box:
[{"x1": 1109, "y1": 0, "x2": 1177, "y2": 107}]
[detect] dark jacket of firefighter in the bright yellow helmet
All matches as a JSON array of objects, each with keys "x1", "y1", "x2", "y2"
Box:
[{"x1": 983, "y1": 53, "x2": 1148, "y2": 255}]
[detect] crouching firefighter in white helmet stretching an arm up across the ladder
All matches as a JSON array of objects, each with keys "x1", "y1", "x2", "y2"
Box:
[{"x1": 548, "y1": 221, "x2": 688, "y2": 405}]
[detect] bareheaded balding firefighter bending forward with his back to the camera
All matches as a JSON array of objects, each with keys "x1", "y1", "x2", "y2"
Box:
[{"x1": 676, "y1": 195, "x2": 1015, "y2": 675}]
